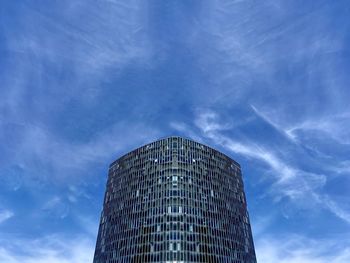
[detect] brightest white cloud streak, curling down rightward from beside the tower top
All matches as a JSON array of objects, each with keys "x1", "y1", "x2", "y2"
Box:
[{"x1": 195, "y1": 111, "x2": 350, "y2": 223}]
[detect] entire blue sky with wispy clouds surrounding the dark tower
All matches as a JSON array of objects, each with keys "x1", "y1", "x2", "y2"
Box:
[{"x1": 0, "y1": 0, "x2": 350, "y2": 263}]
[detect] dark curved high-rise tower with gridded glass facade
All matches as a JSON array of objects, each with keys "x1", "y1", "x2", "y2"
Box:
[{"x1": 94, "y1": 137, "x2": 256, "y2": 263}]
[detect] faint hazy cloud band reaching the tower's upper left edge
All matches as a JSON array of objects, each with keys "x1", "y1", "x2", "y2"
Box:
[{"x1": 0, "y1": 122, "x2": 158, "y2": 185}]
